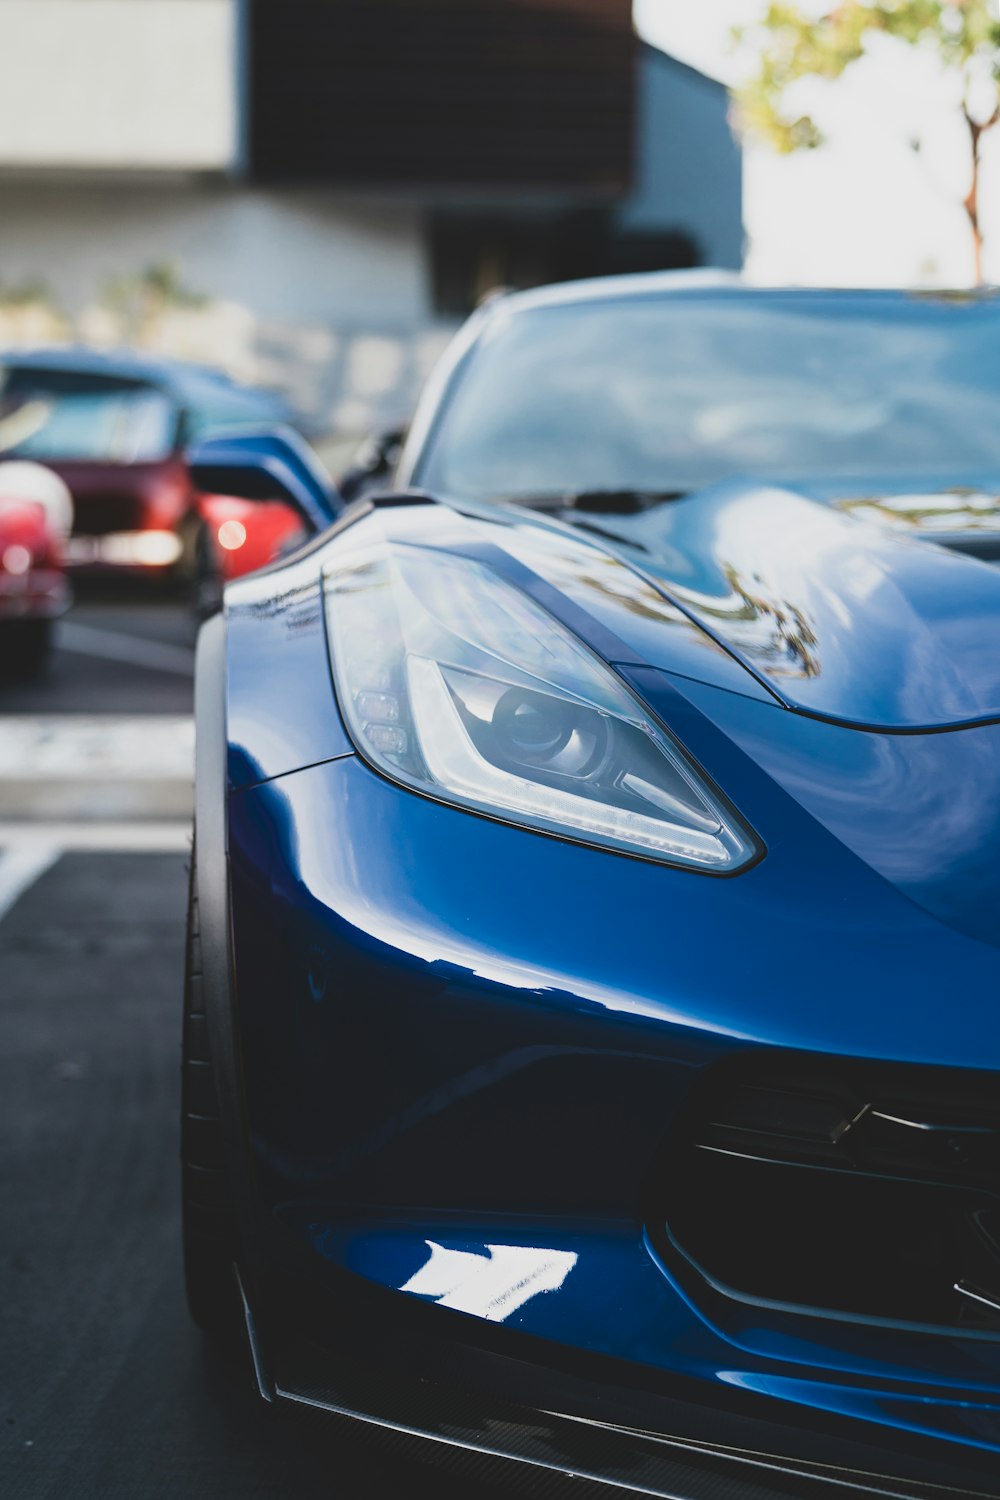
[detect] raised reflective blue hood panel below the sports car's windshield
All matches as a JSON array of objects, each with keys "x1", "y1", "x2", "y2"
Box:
[{"x1": 551, "y1": 482, "x2": 1000, "y2": 731}]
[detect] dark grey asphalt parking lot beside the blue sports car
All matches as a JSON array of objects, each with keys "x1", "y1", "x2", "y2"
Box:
[{"x1": 0, "y1": 600, "x2": 515, "y2": 1500}]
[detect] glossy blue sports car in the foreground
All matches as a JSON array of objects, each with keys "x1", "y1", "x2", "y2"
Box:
[{"x1": 183, "y1": 276, "x2": 1000, "y2": 1500}]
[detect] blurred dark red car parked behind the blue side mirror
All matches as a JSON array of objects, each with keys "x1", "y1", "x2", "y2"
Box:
[{"x1": 0, "y1": 350, "x2": 289, "y2": 582}]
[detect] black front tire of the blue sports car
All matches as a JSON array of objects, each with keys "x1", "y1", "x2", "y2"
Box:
[{"x1": 180, "y1": 849, "x2": 243, "y2": 1346}]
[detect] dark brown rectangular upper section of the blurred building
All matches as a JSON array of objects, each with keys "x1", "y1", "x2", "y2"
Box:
[{"x1": 247, "y1": 0, "x2": 636, "y2": 197}]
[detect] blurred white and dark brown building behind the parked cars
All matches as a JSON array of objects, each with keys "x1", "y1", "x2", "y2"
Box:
[{"x1": 0, "y1": 0, "x2": 742, "y2": 432}]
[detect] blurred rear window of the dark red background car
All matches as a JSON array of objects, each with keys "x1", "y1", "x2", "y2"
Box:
[{"x1": 0, "y1": 366, "x2": 177, "y2": 464}]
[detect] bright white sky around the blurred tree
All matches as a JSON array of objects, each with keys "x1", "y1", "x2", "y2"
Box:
[{"x1": 634, "y1": 0, "x2": 1000, "y2": 287}]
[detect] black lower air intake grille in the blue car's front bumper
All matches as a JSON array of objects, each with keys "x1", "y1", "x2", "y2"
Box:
[{"x1": 649, "y1": 1062, "x2": 1000, "y2": 1337}]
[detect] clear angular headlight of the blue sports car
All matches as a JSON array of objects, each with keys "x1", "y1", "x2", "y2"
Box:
[{"x1": 325, "y1": 545, "x2": 757, "y2": 875}]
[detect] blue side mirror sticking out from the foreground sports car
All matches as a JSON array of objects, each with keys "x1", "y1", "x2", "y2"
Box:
[{"x1": 186, "y1": 428, "x2": 345, "y2": 533}]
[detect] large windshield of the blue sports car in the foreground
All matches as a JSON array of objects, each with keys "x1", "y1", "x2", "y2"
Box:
[{"x1": 415, "y1": 293, "x2": 1000, "y2": 503}]
